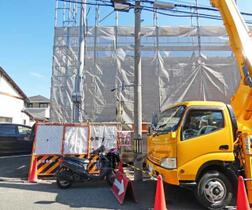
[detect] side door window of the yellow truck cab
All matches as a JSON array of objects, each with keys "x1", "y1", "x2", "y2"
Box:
[{"x1": 182, "y1": 110, "x2": 224, "y2": 140}]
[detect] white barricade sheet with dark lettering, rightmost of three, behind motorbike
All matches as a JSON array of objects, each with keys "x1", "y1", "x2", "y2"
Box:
[{"x1": 91, "y1": 125, "x2": 117, "y2": 151}]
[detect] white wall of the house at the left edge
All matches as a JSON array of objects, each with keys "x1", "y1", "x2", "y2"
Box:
[{"x1": 0, "y1": 75, "x2": 33, "y2": 125}]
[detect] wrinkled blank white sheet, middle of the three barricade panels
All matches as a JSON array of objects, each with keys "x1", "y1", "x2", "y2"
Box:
[{"x1": 64, "y1": 126, "x2": 88, "y2": 154}]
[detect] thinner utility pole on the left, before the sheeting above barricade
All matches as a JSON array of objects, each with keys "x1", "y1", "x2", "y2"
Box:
[{"x1": 72, "y1": 0, "x2": 86, "y2": 122}]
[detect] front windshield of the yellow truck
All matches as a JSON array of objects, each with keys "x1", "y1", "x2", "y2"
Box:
[{"x1": 154, "y1": 106, "x2": 185, "y2": 133}]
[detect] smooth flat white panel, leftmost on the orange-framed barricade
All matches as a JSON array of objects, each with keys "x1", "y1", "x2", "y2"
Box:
[{"x1": 34, "y1": 125, "x2": 63, "y2": 155}]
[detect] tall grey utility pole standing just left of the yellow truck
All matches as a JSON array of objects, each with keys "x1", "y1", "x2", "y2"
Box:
[{"x1": 134, "y1": 0, "x2": 143, "y2": 181}]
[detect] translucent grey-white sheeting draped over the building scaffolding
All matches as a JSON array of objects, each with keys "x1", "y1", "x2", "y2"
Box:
[{"x1": 51, "y1": 26, "x2": 240, "y2": 123}]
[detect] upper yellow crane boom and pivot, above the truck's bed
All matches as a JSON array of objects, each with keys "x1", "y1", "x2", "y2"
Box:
[{"x1": 211, "y1": 0, "x2": 252, "y2": 129}]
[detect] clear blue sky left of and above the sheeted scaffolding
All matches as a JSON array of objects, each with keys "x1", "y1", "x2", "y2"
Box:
[{"x1": 0, "y1": 0, "x2": 252, "y2": 97}]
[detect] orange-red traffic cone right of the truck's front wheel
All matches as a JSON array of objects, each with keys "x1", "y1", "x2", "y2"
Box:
[{"x1": 236, "y1": 176, "x2": 250, "y2": 210}]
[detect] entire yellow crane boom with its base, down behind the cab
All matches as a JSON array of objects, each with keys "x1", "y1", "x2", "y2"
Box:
[{"x1": 211, "y1": 0, "x2": 252, "y2": 203}]
